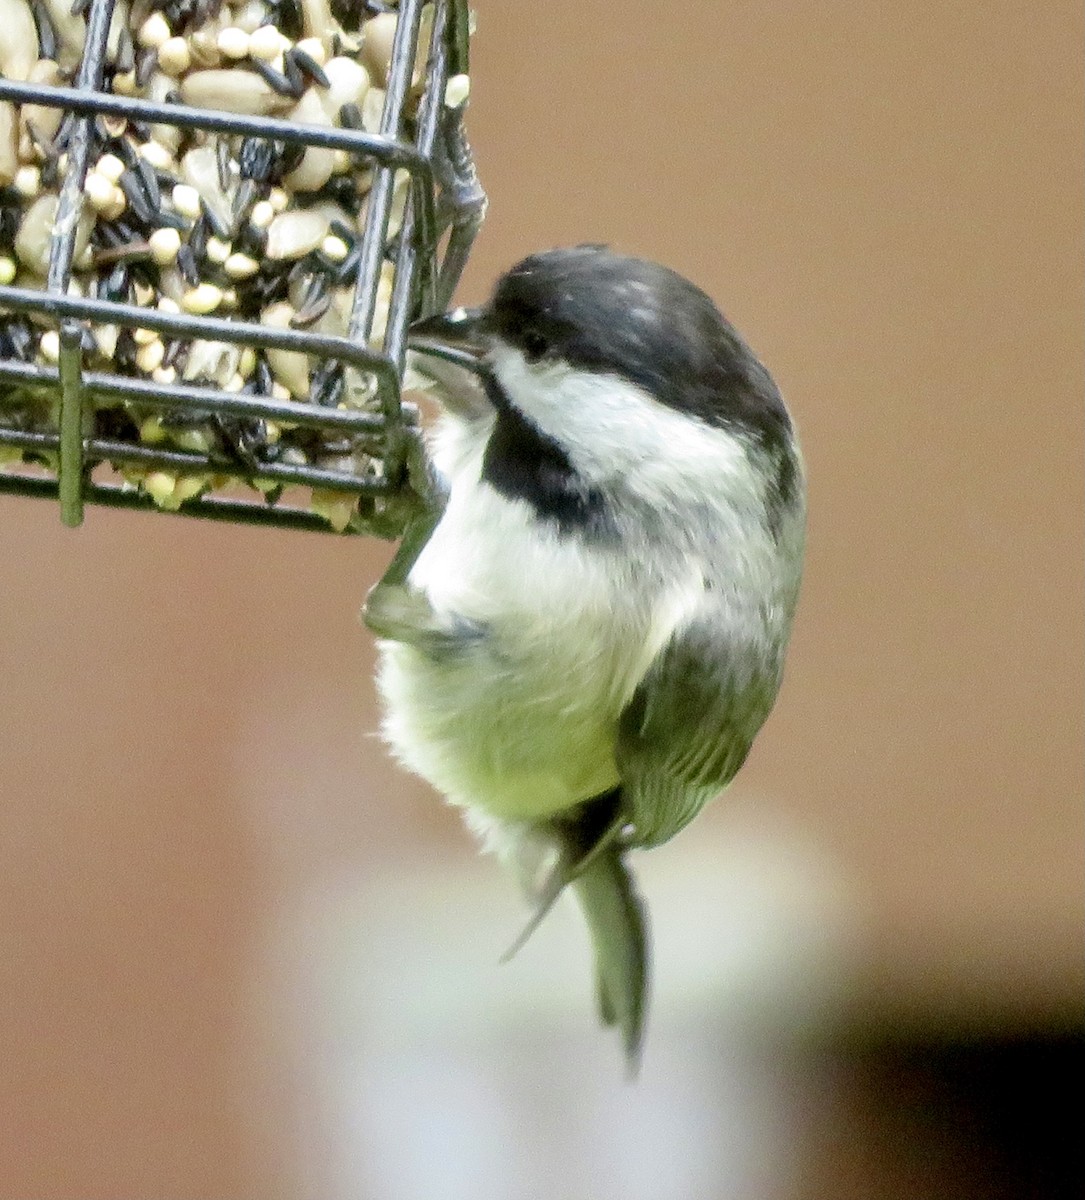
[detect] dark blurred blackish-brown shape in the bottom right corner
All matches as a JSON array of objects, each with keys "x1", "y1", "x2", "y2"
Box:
[{"x1": 799, "y1": 1024, "x2": 1085, "y2": 1200}]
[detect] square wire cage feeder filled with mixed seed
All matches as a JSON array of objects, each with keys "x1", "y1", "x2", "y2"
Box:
[{"x1": 0, "y1": 0, "x2": 485, "y2": 536}]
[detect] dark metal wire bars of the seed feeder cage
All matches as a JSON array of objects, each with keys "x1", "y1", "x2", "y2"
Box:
[{"x1": 0, "y1": 0, "x2": 485, "y2": 536}]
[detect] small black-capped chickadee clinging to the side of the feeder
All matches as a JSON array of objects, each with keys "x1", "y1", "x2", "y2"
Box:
[{"x1": 364, "y1": 245, "x2": 805, "y2": 1069}]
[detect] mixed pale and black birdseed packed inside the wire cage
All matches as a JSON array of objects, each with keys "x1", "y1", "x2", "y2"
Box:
[{"x1": 0, "y1": 0, "x2": 467, "y2": 529}]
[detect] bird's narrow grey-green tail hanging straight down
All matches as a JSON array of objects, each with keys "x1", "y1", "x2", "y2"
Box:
[{"x1": 571, "y1": 845, "x2": 649, "y2": 1074}]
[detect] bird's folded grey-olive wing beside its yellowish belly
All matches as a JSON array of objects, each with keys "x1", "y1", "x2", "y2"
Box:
[{"x1": 616, "y1": 592, "x2": 781, "y2": 846}]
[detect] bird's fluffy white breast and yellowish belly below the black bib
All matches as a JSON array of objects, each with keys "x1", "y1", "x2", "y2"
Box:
[{"x1": 379, "y1": 463, "x2": 669, "y2": 820}]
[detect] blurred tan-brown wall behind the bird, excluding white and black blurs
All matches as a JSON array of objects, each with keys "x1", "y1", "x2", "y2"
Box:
[{"x1": 0, "y1": 0, "x2": 1085, "y2": 1196}]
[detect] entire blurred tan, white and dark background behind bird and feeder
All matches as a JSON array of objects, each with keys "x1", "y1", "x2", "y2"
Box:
[{"x1": 0, "y1": 0, "x2": 1085, "y2": 1200}]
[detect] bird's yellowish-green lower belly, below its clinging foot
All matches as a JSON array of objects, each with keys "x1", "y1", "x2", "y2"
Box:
[{"x1": 378, "y1": 642, "x2": 618, "y2": 821}]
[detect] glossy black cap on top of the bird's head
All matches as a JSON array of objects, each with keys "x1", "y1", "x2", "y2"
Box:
[{"x1": 486, "y1": 245, "x2": 791, "y2": 449}]
